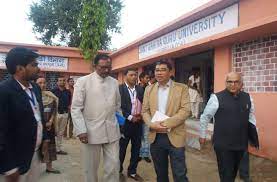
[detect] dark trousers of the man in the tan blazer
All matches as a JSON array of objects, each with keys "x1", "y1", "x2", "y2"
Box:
[{"x1": 150, "y1": 134, "x2": 188, "y2": 182}]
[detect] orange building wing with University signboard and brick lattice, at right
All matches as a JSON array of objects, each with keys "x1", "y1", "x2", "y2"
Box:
[{"x1": 111, "y1": 0, "x2": 277, "y2": 161}]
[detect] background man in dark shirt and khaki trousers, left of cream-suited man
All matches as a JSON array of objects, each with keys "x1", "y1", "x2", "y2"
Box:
[{"x1": 52, "y1": 76, "x2": 71, "y2": 155}]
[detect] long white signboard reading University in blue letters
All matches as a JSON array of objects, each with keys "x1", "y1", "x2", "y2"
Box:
[{"x1": 139, "y1": 4, "x2": 239, "y2": 59}]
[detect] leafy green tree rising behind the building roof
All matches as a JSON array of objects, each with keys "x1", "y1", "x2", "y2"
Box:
[{"x1": 28, "y1": 0, "x2": 122, "y2": 59}]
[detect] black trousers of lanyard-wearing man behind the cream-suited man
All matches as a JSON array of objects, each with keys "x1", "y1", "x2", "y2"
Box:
[{"x1": 119, "y1": 127, "x2": 141, "y2": 174}]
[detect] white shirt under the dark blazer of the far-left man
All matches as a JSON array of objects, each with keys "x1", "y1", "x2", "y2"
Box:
[{"x1": 5, "y1": 80, "x2": 43, "y2": 176}]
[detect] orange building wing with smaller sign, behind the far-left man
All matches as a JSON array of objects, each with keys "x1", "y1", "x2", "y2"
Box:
[{"x1": 0, "y1": 42, "x2": 109, "y2": 89}]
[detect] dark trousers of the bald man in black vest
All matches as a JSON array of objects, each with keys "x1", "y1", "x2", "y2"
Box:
[{"x1": 214, "y1": 148, "x2": 245, "y2": 182}]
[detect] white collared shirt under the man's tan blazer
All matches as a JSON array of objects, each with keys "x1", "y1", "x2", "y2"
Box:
[{"x1": 158, "y1": 80, "x2": 172, "y2": 114}]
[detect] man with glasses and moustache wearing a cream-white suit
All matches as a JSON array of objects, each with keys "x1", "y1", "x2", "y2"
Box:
[{"x1": 71, "y1": 55, "x2": 121, "y2": 182}]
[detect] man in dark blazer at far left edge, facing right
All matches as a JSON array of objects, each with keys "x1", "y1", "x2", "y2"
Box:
[{"x1": 0, "y1": 47, "x2": 49, "y2": 182}]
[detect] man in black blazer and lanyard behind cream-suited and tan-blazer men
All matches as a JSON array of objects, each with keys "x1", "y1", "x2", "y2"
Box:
[{"x1": 119, "y1": 69, "x2": 143, "y2": 181}]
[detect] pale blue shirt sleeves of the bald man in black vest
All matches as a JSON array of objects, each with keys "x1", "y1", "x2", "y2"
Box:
[{"x1": 200, "y1": 94, "x2": 256, "y2": 138}]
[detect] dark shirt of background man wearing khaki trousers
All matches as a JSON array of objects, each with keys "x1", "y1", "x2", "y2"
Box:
[{"x1": 52, "y1": 88, "x2": 71, "y2": 114}]
